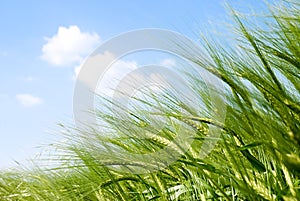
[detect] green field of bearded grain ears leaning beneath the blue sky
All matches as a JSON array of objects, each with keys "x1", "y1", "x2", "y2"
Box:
[{"x1": 0, "y1": 1, "x2": 300, "y2": 201}]
